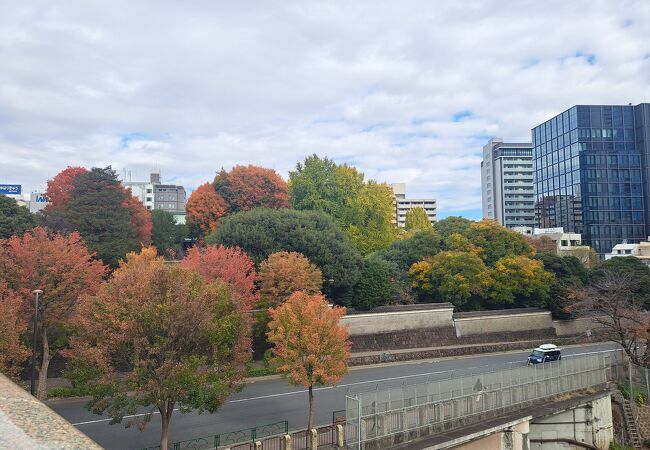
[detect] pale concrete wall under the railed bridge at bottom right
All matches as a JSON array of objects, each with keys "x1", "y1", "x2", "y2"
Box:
[{"x1": 529, "y1": 395, "x2": 614, "y2": 450}]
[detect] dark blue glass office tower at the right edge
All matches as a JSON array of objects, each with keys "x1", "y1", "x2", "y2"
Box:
[{"x1": 532, "y1": 104, "x2": 650, "y2": 257}]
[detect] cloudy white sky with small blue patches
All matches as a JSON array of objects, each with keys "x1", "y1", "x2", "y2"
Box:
[{"x1": 0, "y1": 0, "x2": 650, "y2": 218}]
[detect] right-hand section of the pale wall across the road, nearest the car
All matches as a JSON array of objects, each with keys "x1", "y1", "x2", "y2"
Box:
[{"x1": 454, "y1": 308, "x2": 553, "y2": 336}]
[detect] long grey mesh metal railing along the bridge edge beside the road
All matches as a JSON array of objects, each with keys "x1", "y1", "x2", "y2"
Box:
[{"x1": 345, "y1": 352, "x2": 624, "y2": 448}]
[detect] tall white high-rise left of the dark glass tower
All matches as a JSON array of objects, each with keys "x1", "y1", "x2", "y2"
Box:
[{"x1": 481, "y1": 138, "x2": 535, "y2": 228}]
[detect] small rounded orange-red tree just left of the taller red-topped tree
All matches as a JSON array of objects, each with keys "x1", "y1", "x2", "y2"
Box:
[{"x1": 185, "y1": 183, "x2": 228, "y2": 237}]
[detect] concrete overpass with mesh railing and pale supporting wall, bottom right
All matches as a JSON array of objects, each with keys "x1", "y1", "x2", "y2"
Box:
[{"x1": 345, "y1": 352, "x2": 627, "y2": 450}]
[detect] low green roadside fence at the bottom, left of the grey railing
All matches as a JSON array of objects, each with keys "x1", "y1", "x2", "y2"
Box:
[{"x1": 140, "y1": 420, "x2": 289, "y2": 450}]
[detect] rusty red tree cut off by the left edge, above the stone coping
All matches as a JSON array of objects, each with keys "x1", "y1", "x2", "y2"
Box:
[{"x1": 0, "y1": 280, "x2": 29, "y2": 378}]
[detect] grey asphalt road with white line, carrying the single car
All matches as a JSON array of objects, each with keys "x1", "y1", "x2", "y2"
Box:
[{"x1": 49, "y1": 344, "x2": 615, "y2": 450}]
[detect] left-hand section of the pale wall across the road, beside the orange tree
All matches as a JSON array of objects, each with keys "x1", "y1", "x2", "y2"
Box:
[{"x1": 341, "y1": 304, "x2": 454, "y2": 336}]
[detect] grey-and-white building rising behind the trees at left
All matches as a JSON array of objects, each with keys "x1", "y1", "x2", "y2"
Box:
[{"x1": 122, "y1": 172, "x2": 187, "y2": 213}]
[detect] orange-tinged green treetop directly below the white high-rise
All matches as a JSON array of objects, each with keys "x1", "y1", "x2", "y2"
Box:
[{"x1": 462, "y1": 219, "x2": 535, "y2": 266}]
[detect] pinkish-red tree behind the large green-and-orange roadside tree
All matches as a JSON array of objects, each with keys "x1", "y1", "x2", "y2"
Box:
[{"x1": 181, "y1": 245, "x2": 258, "y2": 311}]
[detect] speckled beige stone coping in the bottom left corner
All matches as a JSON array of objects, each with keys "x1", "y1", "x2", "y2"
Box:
[{"x1": 0, "y1": 373, "x2": 101, "y2": 450}]
